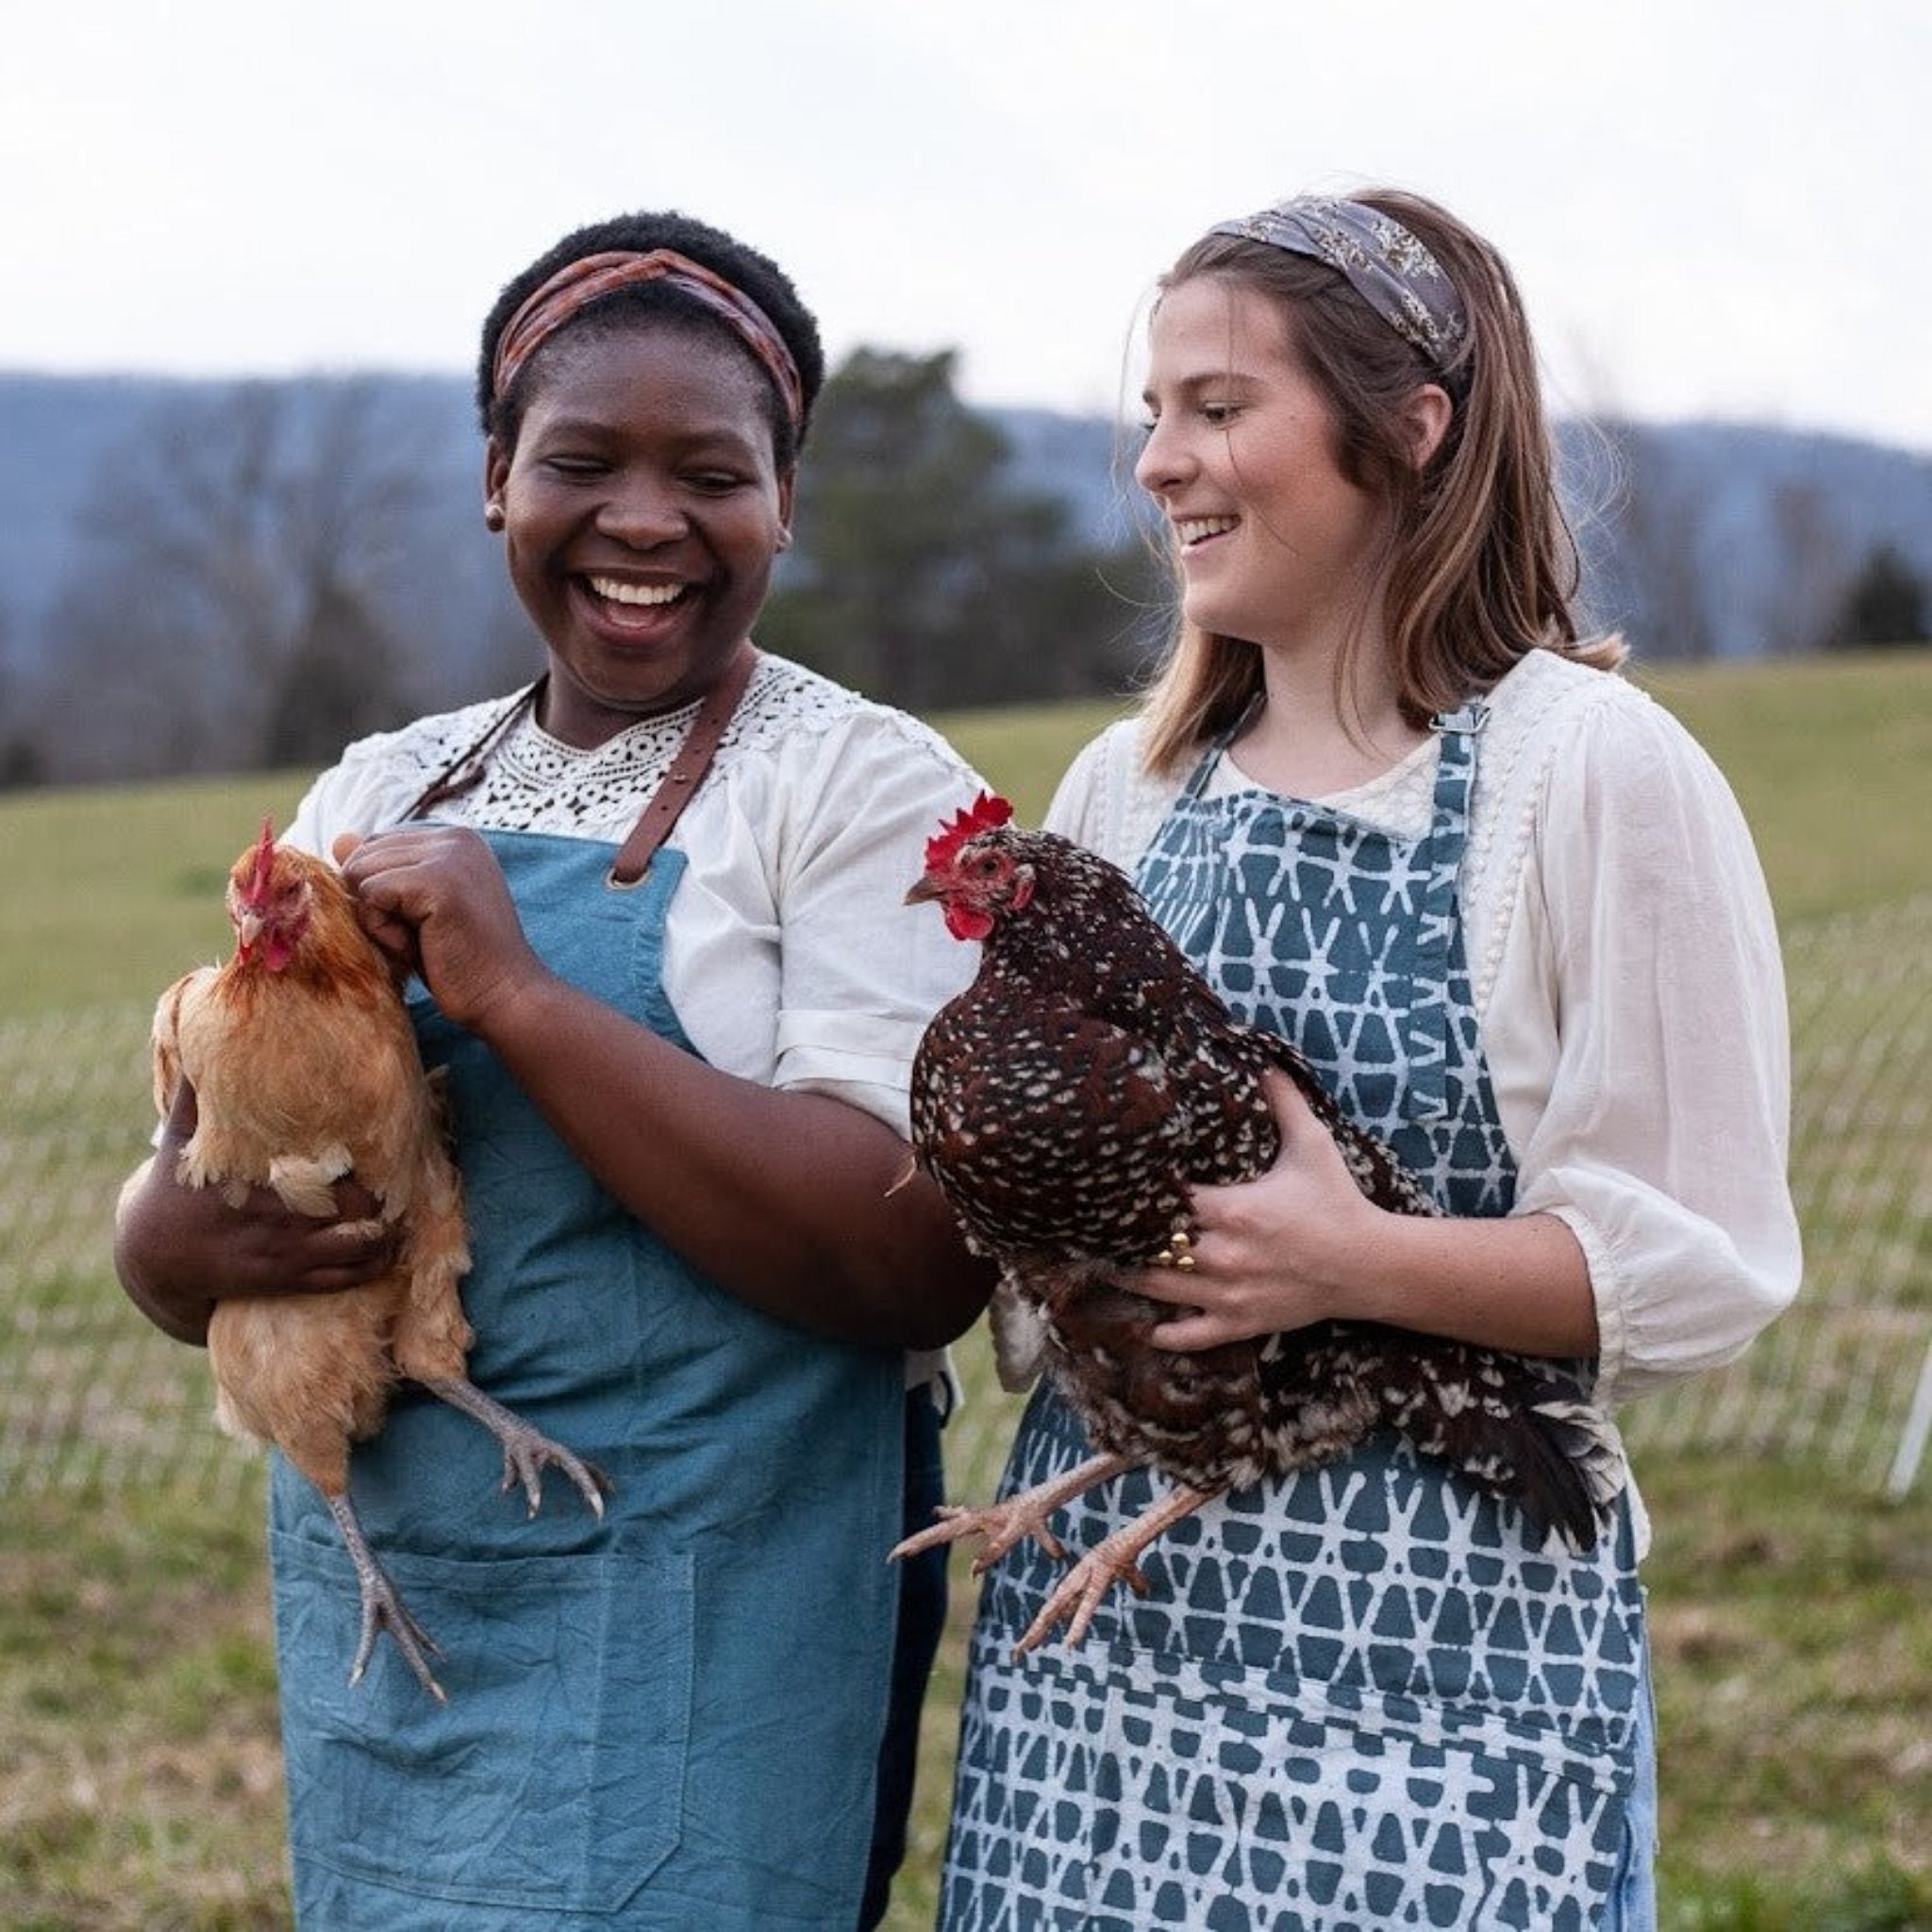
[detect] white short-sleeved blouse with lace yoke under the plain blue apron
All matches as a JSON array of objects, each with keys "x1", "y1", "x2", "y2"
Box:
[{"x1": 290, "y1": 655, "x2": 979, "y2": 1136}]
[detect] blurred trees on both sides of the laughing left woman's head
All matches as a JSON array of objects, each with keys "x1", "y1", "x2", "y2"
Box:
[{"x1": 0, "y1": 350, "x2": 1163, "y2": 787}]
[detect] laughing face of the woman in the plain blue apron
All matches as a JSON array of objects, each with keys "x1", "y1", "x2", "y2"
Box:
[{"x1": 485, "y1": 321, "x2": 792, "y2": 746}]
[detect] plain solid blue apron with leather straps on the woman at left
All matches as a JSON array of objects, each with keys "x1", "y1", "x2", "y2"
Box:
[{"x1": 271, "y1": 833, "x2": 904, "y2": 1932}]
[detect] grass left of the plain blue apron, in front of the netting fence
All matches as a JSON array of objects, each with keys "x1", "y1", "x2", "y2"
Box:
[{"x1": 0, "y1": 1484, "x2": 288, "y2": 1932}]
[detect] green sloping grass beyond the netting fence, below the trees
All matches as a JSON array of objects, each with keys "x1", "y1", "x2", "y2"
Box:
[{"x1": 0, "y1": 651, "x2": 1932, "y2": 1014}]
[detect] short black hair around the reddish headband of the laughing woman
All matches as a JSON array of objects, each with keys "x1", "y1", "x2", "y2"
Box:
[{"x1": 475, "y1": 208, "x2": 824, "y2": 470}]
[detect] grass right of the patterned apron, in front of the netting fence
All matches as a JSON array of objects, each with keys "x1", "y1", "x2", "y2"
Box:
[{"x1": 1637, "y1": 1455, "x2": 1932, "y2": 1932}]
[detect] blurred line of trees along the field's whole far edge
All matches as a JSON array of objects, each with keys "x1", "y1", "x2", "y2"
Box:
[{"x1": 0, "y1": 358, "x2": 1932, "y2": 787}]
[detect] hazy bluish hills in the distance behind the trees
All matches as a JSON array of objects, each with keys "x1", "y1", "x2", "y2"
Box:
[{"x1": 0, "y1": 373, "x2": 1932, "y2": 688}]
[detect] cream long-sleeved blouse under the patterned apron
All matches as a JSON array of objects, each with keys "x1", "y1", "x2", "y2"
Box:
[{"x1": 1047, "y1": 651, "x2": 1801, "y2": 1403}]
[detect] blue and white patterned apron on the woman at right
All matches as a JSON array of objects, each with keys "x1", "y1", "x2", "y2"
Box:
[{"x1": 941, "y1": 708, "x2": 1646, "y2": 1932}]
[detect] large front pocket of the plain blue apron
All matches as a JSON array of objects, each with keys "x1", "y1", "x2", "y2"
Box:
[{"x1": 271, "y1": 1532, "x2": 691, "y2": 1919}]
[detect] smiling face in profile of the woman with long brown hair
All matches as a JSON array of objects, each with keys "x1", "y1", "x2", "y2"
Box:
[{"x1": 1134, "y1": 276, "x2": 1390, "y2": 664}]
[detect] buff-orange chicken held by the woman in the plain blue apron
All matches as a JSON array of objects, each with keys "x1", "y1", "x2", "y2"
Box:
[{"x1": 142, "y1": 823, "x2": 605, "y2": 1700}]
